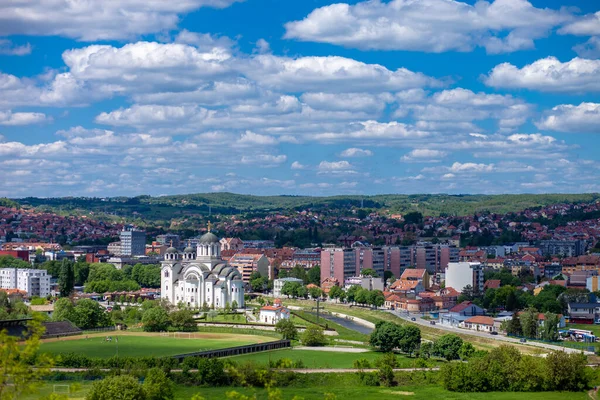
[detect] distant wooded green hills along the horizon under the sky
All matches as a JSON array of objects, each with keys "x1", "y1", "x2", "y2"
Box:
[{"x1": 15, "y1": 193, "x2": 600, "y2": 221}]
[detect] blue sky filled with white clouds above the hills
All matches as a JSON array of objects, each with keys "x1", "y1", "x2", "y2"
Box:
[{"x1": 0, "y1": 0, "x2": 600, "y2": 197}]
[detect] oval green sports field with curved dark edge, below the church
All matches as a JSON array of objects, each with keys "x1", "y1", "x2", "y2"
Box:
[{"x1": 40, "y1": 332, "x2": 273, "y2": 358}]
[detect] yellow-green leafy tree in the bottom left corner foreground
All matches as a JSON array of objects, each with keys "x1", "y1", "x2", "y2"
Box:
[{"x1": 0, "y1": 317, "x2": 53, "y2": 400}]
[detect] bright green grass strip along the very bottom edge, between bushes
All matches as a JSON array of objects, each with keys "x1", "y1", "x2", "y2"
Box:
[{"x1": 22, "y1": 382, "x2": 589, "y2": 400}]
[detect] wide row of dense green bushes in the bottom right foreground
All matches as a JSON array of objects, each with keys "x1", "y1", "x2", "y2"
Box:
[{"x1": 440, "y1": 345, "x2": 594, "y2": 392}]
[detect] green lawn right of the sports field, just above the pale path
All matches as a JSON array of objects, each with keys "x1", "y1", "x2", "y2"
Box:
[{"x1": 230, "y1": 349, "x2": 439, "y2": 368}]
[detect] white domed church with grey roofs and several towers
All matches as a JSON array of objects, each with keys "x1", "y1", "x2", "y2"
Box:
[{"x1": 161, "y1": 228, "x2": 244, "y2": 308}]
